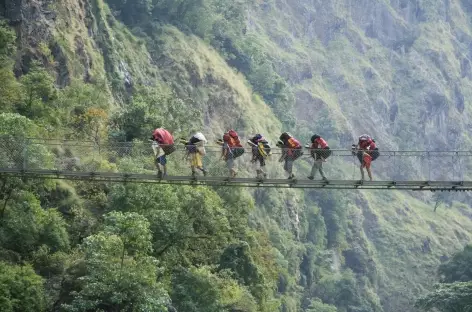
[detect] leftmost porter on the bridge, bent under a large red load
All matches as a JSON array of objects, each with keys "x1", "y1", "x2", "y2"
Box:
[{"x1": 151, "y1": 128, "x2": 175, "y2": 179}]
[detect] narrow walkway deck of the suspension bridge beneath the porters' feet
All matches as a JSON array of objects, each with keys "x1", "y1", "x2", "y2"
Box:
[{"x1": 0, "y1": 168, "x2": 472, "y2": 191}]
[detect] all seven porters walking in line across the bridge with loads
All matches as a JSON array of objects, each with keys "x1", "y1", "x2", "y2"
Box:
[{"x1": 151, "y1": 128, "x2": 380, "y2": 181}]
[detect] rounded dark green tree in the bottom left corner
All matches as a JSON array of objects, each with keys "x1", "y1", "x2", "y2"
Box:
[{"x1": 0, "y1": 261, "x2": 45, "y2": 312}]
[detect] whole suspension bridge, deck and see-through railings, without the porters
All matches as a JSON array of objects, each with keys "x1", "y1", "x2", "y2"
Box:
[{"x1": 0, "y1": 137, "x2": 472, "y2": 191}]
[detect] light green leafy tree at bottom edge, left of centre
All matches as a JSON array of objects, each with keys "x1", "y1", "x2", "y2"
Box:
[{"x1": 62, "y1": 212, "x2": 168, "y2": 312}]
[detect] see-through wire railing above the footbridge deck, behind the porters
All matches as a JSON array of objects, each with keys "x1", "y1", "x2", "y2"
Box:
[{"x1": 0, "y1": 137, "x2": 472, "y2": 181}]
